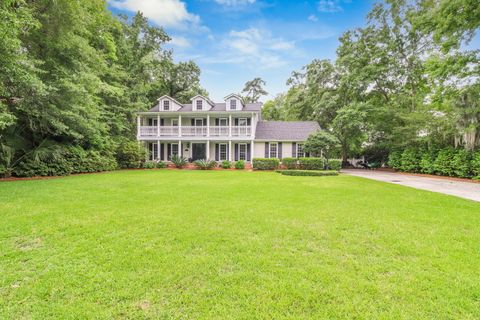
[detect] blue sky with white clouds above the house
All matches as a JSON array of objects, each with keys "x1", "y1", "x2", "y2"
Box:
[{"x1": 108, "y1": 0, "x2": 382, "y2": 101}]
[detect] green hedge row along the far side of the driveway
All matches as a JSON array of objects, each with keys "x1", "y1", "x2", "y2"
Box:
[{"x1": 388, "y1": 148, "x2": 480, "y2": 178}]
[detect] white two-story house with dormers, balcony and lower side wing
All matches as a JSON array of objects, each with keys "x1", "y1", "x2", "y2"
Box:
[{"x1": 137, "y1": 94, "x2": 319, "y2": 162}]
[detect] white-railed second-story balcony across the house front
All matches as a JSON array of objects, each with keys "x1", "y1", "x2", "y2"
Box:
[{"x1": 138, "y1": 126, "x2": 252, "y2": 138}]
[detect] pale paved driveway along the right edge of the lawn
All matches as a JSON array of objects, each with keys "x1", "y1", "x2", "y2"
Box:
[{"x1": 342, "y1": 169, "x2": 480, "y2": 202}]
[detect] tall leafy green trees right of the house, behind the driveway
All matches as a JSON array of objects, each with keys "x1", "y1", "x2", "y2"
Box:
[{"x1": 263, "y1": 0, "x2": 480, "y2": 168}]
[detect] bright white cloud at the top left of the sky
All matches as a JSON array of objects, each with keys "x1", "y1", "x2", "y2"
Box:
[{"x1": 109, "y1": 0, "x2": 200, "y2": 29}]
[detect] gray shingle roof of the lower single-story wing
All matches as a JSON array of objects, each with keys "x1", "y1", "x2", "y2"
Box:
[{"x1": 255, "y1": 121, "x2": 320, "y2": 141}]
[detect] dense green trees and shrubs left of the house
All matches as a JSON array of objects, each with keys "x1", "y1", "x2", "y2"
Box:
[{"x1": 0, "y1": 0, "x2": 207, "y2": 176}]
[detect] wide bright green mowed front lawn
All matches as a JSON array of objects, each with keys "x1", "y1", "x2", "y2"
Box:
[{"x1": 0, "y1": 170, "x2": 480, "y2": 319}]
